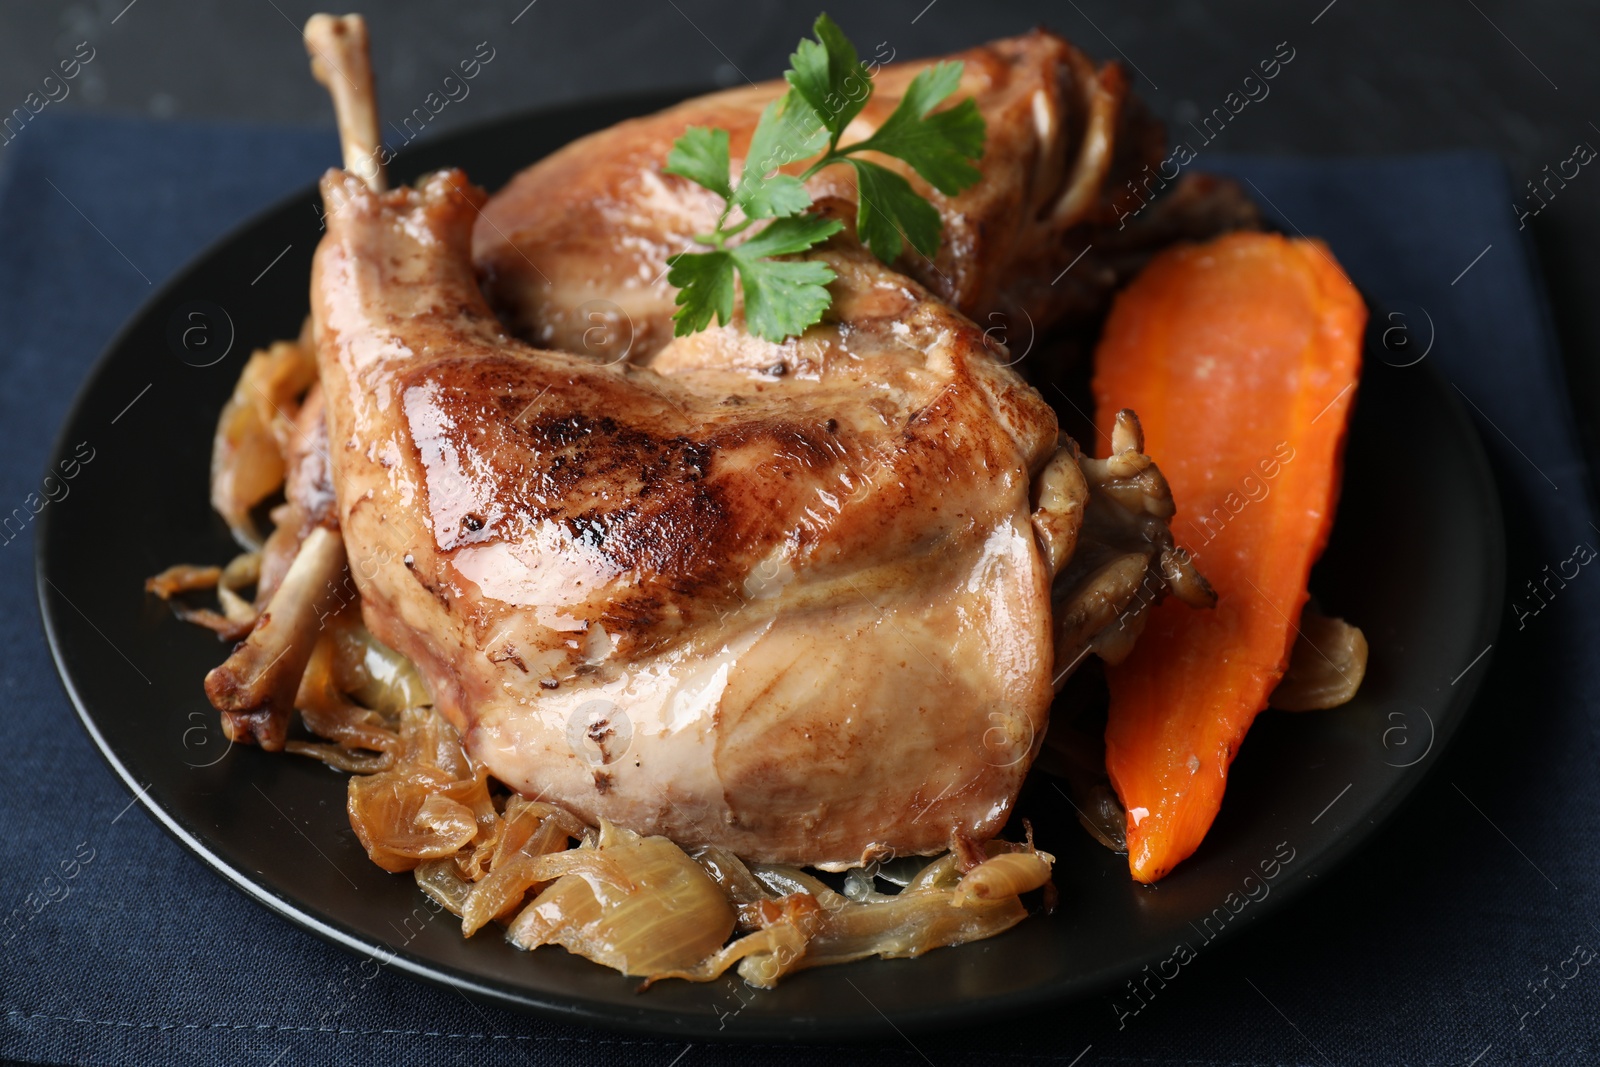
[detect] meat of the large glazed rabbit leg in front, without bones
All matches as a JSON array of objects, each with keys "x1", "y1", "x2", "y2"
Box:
[{"x1": 314, "y1": 173, "x2": 1100, "y2": 867}]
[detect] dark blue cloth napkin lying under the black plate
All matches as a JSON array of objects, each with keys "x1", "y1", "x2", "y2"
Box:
[{"x1": 0, "y1": 115, "x2": 1600, "y2": 1067}]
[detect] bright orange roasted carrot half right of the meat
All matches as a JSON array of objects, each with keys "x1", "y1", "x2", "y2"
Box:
[{"x1": 1094, "y1": 234, "x2": 1366, "y2": 883}]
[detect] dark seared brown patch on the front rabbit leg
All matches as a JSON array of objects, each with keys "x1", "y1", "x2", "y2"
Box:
[{"x1": 400, "y1": 354, "x2": 870, "y2": 638}]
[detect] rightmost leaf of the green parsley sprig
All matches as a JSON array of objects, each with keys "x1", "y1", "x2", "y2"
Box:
[{"x1": 850, "y1": 62, "x2": 987, "y2": 195}]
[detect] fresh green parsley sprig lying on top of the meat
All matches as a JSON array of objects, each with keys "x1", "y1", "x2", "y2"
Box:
[{"x1": 664, "y1": 14, "x2": 986, "y2": 341}]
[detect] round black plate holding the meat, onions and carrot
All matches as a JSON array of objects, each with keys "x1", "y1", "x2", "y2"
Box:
[{"x1": 38, "y1": 96, "x2": 1504, "y2": 1038}]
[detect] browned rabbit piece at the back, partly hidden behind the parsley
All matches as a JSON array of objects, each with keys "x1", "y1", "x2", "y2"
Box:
[{"x1": 474, "y1": 30, "x2": 1165, "y2": 362}]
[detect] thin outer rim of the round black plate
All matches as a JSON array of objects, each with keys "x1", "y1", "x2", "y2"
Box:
[{"x1": 34, "y1": 86, "x2": 1507, "y2": 1045}]
